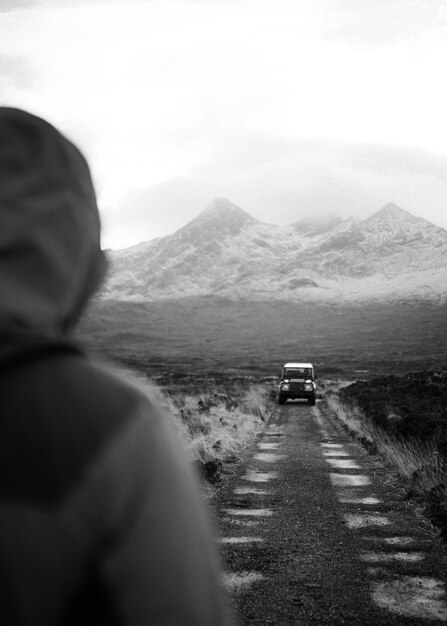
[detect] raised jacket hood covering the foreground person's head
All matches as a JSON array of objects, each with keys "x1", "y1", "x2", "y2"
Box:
[{"x1": 0, "y1": 107, "x2": 105, "y2": 348}]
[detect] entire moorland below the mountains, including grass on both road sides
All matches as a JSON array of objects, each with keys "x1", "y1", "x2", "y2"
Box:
[{"x1": 83, "y1": 296, "x2": 447, "y2": 537}]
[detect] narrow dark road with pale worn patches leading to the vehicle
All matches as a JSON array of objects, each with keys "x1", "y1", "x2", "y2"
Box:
[{"x1": 213, "y1": 402, "x2": 447, "y2": 626}]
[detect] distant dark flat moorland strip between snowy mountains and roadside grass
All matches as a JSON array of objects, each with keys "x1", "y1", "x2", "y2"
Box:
[{"x1": 79, "y1": 296, "x2": 447, "y2": 379}]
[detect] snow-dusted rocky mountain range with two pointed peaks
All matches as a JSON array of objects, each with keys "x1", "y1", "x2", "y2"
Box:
[{"x1": 103, "y1": 198, "x2": 447, "y2": 300}]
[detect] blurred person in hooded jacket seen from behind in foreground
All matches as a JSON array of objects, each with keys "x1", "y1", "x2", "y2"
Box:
[{"x1": 0, "y1": 108, "x2": 228, "y2": 626}]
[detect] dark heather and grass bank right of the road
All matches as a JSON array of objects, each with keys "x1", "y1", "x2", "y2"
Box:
[{"x1": 326, "y1": 370, "x2": 447, "y2": 539}]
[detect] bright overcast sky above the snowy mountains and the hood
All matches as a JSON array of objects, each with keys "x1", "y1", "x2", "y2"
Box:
[{"x1": 0, "y1": 0, "x2": 447, "y2": 248}]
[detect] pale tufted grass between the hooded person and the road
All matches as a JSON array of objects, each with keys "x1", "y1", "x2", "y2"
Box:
[{"x1": 114, "y1": 368, "x2": 273, "y2": 483}]
